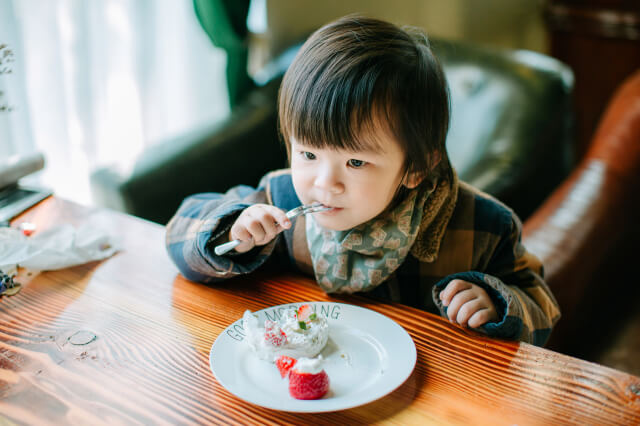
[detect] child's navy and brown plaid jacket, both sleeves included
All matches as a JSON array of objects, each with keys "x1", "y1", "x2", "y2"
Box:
[{"x1": 166, "y1": 170, "x2": 560, "y2": 345}]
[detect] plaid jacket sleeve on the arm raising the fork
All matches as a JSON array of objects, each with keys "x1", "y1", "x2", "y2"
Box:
[{"x1": 165, "y1": 175, "x2": 278, "y2": 282}]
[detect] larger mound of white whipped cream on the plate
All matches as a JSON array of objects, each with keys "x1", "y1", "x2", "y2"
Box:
[{"x1": 242, "y1": 308, "x2": 329, "y2": 362}]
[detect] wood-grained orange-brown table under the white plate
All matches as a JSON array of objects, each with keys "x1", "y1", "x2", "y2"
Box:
[{"x1": 0, "y1": 198, "x2": 640, "y2": 425}]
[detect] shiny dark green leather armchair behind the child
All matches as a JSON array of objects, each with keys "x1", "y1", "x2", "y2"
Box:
[{"x1": 91, "y1": 5, "x2": 573, "y2": 224}]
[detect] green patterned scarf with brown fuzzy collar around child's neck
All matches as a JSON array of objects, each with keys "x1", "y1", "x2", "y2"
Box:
[{"x1": 306, "y1": 176, "x2": 457, "y2": 293}]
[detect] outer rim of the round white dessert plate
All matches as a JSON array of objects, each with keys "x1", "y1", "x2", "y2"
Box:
[{"x1": 209, "y1": 300, "x2": 417, "y2": 413}]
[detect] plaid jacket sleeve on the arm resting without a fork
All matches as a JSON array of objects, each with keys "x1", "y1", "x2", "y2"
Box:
[{"x1": 433, "y1": 215, "x2": 560, "y2": 346}]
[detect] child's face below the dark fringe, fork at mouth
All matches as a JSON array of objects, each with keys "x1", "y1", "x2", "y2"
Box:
[{"x1": 291, "y1": 131, "x2": 405, "y2": 231}]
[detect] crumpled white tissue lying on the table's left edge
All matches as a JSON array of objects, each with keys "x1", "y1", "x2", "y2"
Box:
[{"x1": 0, "y1": 223, "x2": 119, "y2": 274}]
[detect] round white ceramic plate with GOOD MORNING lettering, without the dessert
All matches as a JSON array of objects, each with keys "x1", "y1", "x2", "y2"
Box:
[{"x1": 209, "y1": 302, "x2": 416, "y2": 413}]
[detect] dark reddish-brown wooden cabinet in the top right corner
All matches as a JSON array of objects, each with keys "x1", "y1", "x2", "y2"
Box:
[{"x1": 545, "y1": 0, "x2": 640, "y2": 161}]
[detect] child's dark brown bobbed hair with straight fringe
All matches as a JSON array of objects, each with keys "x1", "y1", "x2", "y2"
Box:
[{"x1": 279, "y1": 15, "x2": 453, "y2": 181}]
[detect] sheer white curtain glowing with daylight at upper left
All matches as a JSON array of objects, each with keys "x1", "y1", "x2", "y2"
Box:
[{"x1": 0, "y1": 0, "x2": 229, "y2": 204}]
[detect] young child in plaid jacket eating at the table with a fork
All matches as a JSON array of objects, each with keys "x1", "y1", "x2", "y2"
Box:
[{"x1": 166, "y1": 16, "x2": 560, "y2": 345}]
